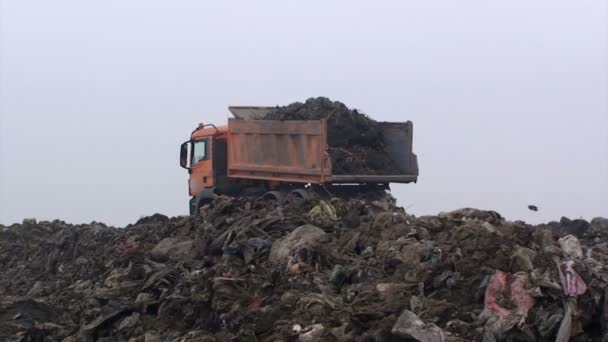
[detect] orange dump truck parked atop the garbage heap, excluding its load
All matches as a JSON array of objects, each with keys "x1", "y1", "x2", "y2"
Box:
[{"x1": 180, "y1": 106, "x2": 418, "y2": 215}]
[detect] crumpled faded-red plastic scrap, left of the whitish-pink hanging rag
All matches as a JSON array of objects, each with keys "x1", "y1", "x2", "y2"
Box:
[{"x1": 485, "y1": 270, "x2": 534, "y2": 322}]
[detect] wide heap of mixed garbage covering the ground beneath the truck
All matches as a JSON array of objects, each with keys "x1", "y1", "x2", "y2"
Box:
[{"x1": 0, "y1": 195, "x2": 608, "y2": 342}]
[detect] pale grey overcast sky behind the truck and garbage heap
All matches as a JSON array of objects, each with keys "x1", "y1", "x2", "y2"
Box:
[{"x1": 0, "y1": 0, "x2": 608, "y2": 226}]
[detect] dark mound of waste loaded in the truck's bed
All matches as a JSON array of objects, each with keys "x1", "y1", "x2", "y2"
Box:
[{"x1": 260, "y1": 97, "x2": 402, "y2": 175}]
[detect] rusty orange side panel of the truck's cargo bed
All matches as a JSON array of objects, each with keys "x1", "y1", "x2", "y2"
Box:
[{"x1": 228, "y1": 119, "x2": 331, "y2": 183}]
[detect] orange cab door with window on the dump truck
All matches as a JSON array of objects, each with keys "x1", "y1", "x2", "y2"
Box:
[{"x1": 190, "y1": 138, "x2": 214, "y2": 196}]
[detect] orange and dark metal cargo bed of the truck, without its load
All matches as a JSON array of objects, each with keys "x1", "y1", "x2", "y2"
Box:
[{"x1": 228, "y1": 119, "x2": 418, "y2": 183}]
